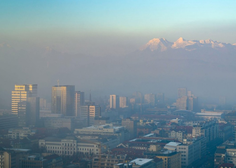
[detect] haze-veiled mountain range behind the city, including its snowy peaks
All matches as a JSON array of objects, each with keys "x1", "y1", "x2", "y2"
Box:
[{"x1": 0, "y1": 38, "x2": 236, "y2": 107}]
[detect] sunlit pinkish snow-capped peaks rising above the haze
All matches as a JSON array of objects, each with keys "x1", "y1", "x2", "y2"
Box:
[{"x1": 140, "y1": 37, "x2": 236, "y2": 52}]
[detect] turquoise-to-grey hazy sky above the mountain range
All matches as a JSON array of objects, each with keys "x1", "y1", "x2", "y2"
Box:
[{"x1": 0, "y1": 0, "x2": 236, "y2": 55}]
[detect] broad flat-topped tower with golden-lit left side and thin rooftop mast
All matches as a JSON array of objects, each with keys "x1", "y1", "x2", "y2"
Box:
[{"x1": 51, "y1": 85, "x2": 75, "y2": 116}]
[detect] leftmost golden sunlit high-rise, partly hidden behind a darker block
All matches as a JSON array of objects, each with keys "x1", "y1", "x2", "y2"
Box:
[{"x1": 11, "y1": 84, "x2": 38, "y2": 115}]
